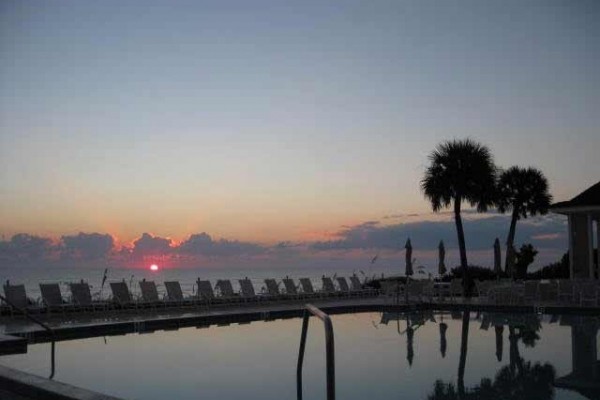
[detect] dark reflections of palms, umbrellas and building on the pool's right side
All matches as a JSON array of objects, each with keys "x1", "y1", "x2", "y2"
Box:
[{"x1": 381, "y1": 311, "x2": 600, "y2": 400}]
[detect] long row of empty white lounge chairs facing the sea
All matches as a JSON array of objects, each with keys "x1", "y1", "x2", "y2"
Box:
[{"x1": 2, "y1": 275, "x2": 378, "y2": 314}]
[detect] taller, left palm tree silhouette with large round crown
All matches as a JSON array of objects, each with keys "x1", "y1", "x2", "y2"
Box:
[{"x1": 421, "y1": 139, "x2": 496, "y2": 294}]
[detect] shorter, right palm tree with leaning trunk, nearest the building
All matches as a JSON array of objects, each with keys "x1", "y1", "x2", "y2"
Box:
[{"x1": 497, "y1": 167, "x2": 552, "y2": 274}]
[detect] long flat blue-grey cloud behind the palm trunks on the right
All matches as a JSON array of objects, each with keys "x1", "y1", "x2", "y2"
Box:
[{"x1": 310, "y1": 215, "x2": 568, "y2": 250}]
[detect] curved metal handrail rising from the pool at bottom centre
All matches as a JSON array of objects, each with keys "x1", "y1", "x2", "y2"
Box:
[{"x1": 296, "y1": 304, "x2": 335, "y2": 400}]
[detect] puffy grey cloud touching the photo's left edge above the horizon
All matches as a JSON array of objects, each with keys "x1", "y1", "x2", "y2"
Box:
[{"x1": 0, "y1": 233, "x2": 55, "y2": 261}]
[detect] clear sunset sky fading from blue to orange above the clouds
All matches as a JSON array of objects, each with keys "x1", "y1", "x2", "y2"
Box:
[{"x1": 0, "y1": 0, "x2": 600, "y2": 268}]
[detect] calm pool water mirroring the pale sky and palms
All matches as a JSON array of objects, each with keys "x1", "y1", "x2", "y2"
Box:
[{"x1": 0, "y1": 312, "x2": 600, "y2": 400}]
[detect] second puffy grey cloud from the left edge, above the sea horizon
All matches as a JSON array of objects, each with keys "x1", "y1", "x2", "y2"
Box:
[{"x1": 62, "y1": 232, "x2": 115, "y2": 260}]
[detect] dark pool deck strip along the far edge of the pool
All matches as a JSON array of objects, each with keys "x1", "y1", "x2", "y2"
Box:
[{"x1": 0, "y1": 296, "x2": 600, "y2": 346}]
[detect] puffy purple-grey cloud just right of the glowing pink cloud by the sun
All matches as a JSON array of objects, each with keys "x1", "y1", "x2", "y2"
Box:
[{"x1": 177, "y1": 232, "x2": 267, "y2": 257}]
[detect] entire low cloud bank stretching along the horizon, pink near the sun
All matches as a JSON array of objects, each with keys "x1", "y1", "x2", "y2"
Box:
[{"x1": 0, "y1": 213, "x2": 568, "y2": 266}]
